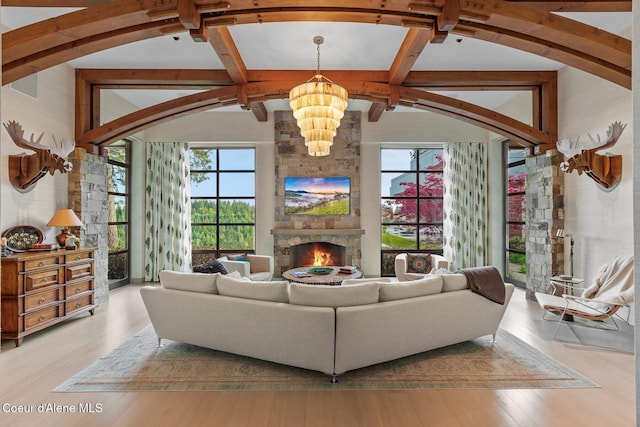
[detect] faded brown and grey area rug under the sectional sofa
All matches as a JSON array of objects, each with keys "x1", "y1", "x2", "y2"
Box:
[{"x1": 55, "y1": 326, "x2": 598, "y2": 392}]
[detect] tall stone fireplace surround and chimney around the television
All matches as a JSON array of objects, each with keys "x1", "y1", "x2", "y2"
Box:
[{"x1": 271, "y1": 111, "x2": 364, "y2": 276}]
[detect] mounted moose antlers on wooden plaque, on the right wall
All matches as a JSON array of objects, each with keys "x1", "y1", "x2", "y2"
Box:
[{"x1": 556, "y1": 121, "x2": 627, "y2": 191}]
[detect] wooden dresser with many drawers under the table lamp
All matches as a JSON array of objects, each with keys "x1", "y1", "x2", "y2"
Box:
[{"x1": 0, "y1": 248, "x2": 96, "y2": 346}]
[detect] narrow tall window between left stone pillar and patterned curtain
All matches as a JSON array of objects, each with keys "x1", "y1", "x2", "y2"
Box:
[{"x1": 107, "y1": 141, "x2": 130, "y2": 289}]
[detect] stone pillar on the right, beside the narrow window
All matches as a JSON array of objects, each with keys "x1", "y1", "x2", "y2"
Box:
[{"x1": 525, "y1": 150, "x2": 564, "y2": 299}]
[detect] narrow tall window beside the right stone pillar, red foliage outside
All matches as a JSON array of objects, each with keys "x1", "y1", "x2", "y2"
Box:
[{"x1": 505, "y1": 143, "x2": 527, "y2": 285}]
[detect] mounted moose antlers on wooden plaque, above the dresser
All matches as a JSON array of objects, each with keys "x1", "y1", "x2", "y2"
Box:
[{"x1": 3, "y1": 120, "x2": 75, "y2": 193}]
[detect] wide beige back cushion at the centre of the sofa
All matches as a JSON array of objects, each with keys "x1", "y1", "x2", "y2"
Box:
[{"x1": 289, "y1": 282, "x2": 380, "y2": 308}]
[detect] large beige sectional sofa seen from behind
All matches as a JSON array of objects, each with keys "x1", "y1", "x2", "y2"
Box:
[{"x1": 141, "y1": 271, "x2": 513, "y2": 380}]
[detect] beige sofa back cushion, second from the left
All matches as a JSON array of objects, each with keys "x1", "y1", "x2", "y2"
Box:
[{"x1": 217, "y1": 276, "x2": 289, "y2": 302}]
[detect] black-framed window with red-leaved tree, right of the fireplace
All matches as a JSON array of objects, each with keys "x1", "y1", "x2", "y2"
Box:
[{"x1": 380, "y1": 148, "x2": 444, "y2": 276}]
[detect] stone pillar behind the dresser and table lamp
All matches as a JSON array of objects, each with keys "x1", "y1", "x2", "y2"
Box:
[{"x1": 68, "y1": 148, "x2": 109, "y2": 304}]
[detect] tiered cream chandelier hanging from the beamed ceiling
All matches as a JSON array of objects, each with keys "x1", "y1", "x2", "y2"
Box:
[{"x1": 289, "y1": 36, "x2": 349, "y2": 156}]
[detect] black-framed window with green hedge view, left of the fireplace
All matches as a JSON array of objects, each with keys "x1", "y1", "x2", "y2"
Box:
[{"x1": 190, "y1": 148, "x2": 256, "y2": 265}]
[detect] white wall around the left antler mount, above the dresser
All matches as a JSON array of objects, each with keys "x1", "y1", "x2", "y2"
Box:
[{"x1": 0, "y1": 65, "x2": 75, "y2": 243}]
